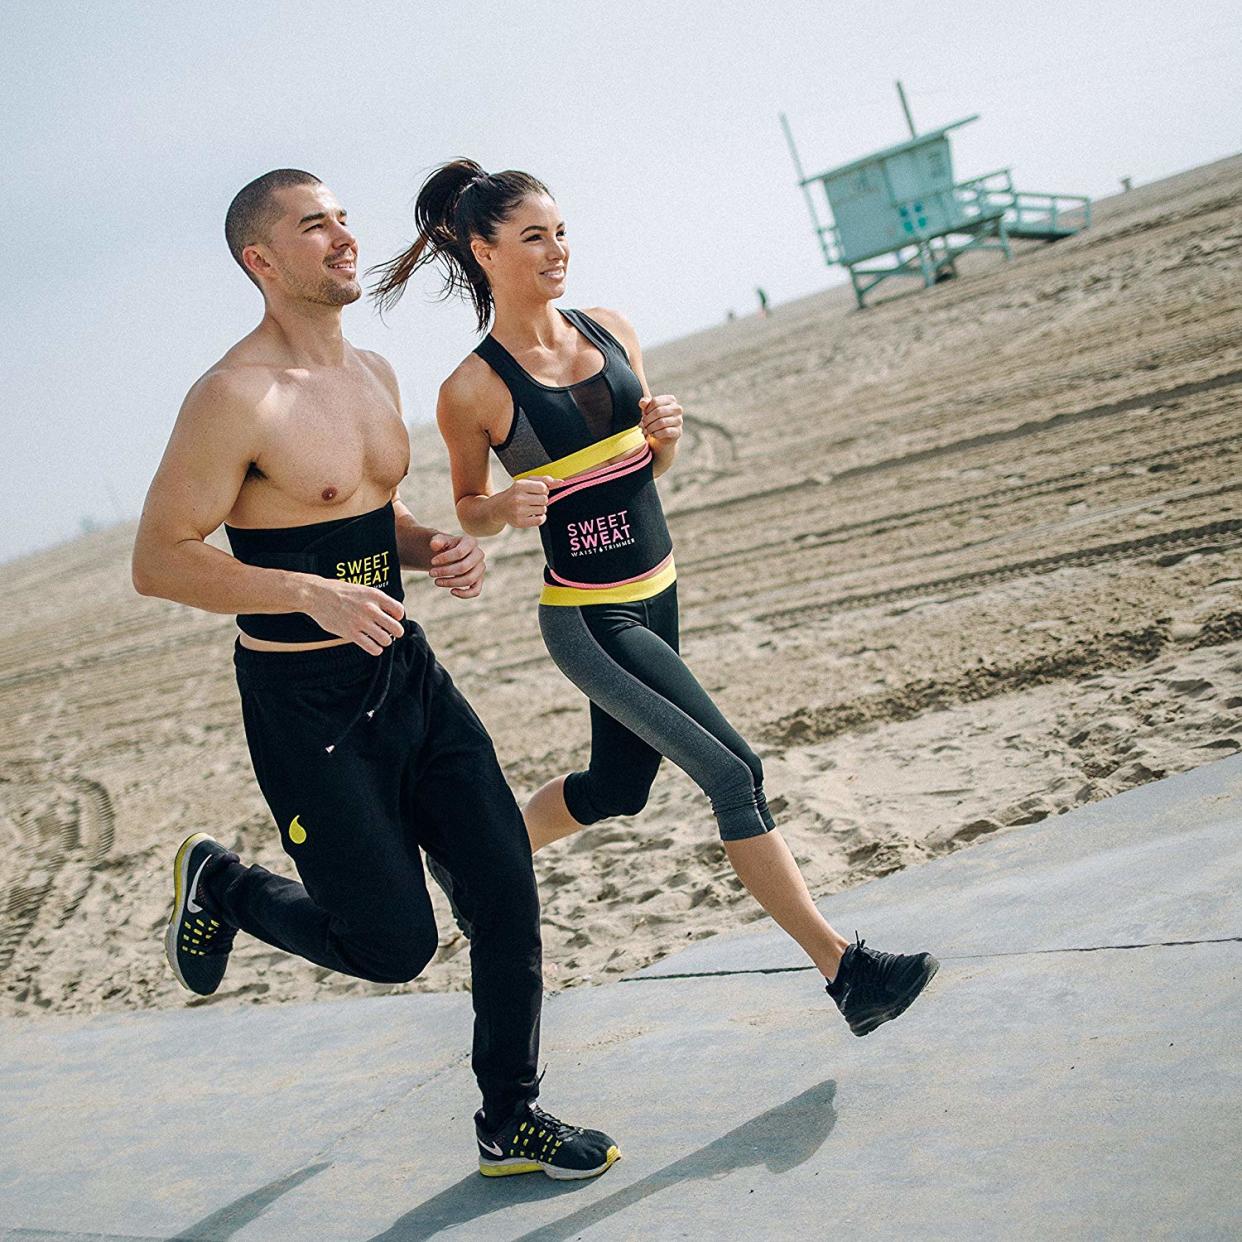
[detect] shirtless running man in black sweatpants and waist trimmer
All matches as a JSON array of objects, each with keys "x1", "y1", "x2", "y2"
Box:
[{"x1": 133, "y1": 169, "x2": 619, "y2": 1179}]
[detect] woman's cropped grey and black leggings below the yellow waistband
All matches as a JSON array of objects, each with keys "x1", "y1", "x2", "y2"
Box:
[{"x1": 539, "y1": 582, "x2": 775, "y2": 841}]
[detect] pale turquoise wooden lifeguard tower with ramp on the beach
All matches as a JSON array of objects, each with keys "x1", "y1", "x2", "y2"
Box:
[{"x1": 780, "y1": 82, "x2": 1090, "y2": 308}]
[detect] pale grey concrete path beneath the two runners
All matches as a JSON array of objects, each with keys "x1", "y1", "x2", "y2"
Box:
[{"x1": 0, "y1": 758, "x2": 1242, "y2": 1242}]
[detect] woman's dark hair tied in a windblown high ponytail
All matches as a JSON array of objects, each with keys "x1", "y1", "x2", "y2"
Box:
[{"x1": 371, "y1": 159, "x2": 550, "y2": 332}]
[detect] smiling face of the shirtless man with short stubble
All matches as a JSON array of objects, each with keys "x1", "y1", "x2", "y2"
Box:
[{"x1": 255, "y1": 185, "x2": 363, "y2": 307}]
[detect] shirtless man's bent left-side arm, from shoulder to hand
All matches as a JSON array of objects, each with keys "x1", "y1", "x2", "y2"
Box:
[{"x1": 132, "y1": 373, "x2": 405, "y2": 656}]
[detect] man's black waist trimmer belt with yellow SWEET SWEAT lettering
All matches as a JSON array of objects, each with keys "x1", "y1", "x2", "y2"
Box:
[{"x1": 225, "y1": 502, "x2": 405, "y2": 642}]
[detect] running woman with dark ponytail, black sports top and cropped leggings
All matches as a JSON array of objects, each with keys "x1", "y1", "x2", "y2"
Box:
[{"x1": 374, "y1": 159, "x2": 936, "y2": 1035}]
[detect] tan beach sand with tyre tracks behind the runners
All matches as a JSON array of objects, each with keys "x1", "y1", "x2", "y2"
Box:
[{"x1": 0, "y1": 158, "x2": 1242, "y2": 1015}]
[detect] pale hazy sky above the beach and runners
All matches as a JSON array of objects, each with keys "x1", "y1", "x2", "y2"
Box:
[{"x1": 0, "y1": 0, "x2": 1242, "y2": 560}]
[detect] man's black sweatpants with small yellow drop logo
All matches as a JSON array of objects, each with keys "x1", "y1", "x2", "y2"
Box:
[{"x1": 205, "y1": 621, "x2": 543, "y2": 1123}]
